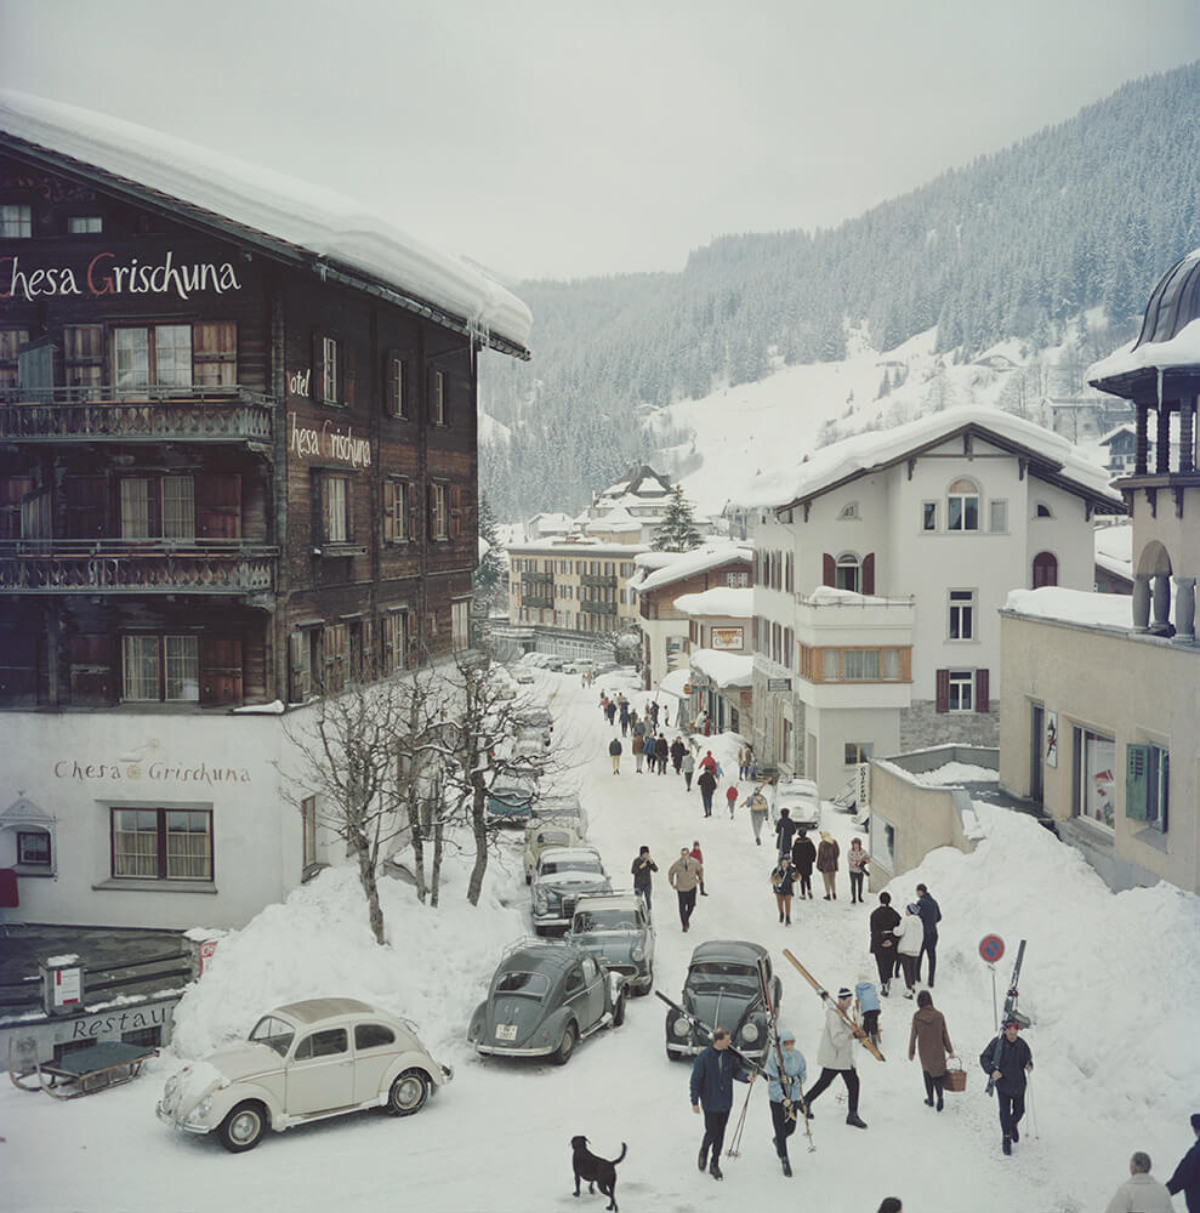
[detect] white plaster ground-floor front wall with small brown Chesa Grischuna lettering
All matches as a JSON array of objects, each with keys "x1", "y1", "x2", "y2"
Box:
[{"x1": 0, "y1": 711, "x2": 302, "y2": 928}]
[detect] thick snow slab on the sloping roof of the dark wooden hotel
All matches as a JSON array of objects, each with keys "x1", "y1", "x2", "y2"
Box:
[{"x1": 0, "y1": 90, "x2": 533, "y2": 352}]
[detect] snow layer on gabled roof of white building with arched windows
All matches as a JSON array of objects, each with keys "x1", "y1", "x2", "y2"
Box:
[{"x1": 738, "y1": 405, "x2": 1124, "y2": 507}]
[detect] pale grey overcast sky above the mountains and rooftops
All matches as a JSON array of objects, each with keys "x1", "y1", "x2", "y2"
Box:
[{"x1": 0, "y1": 0, "x2": 1200, "y2": 279}]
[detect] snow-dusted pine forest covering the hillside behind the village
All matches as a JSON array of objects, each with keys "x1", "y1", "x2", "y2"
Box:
[{"x1": 480, "y1": 63, "x2": 1200, "y2": 519}]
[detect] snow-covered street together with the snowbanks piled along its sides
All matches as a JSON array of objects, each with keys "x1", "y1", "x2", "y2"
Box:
[{"x1": 0, "y1": 671, "x2": 1200, "y2": 1213}]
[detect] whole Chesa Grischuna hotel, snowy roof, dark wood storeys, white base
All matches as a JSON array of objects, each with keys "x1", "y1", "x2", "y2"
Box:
[{"x1": 0, "y1": 93, "x2": 529, "y2": 924}]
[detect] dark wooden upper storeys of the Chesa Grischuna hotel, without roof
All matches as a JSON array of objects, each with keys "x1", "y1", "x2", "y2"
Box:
[{"x1": 0, "y1": 136, "x2": 487, "y2": 710}]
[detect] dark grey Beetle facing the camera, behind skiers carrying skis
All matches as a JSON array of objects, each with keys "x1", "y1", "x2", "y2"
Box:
[{"x1": 666, "y1": 939, "x2": 783, "y2": 1061}]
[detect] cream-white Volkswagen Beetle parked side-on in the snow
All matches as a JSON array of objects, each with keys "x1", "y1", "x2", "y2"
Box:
[{"x1": 157, "y1": 998, "x2": 451, "y2": 1154}]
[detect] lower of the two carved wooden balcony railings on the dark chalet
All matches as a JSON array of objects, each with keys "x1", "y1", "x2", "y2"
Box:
[{"x1": 0, "y1": 540, "x2": 279, "y2": 596}]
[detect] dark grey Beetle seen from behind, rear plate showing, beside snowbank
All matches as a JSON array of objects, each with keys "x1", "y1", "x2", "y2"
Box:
[{"x1": 467, "y1": 940, "x2": 625, "y2": 1065}]
